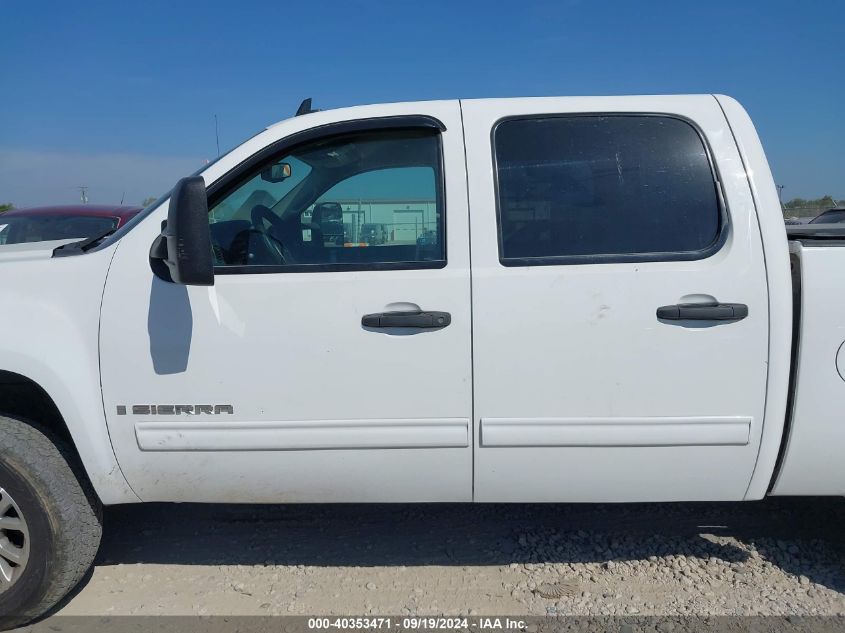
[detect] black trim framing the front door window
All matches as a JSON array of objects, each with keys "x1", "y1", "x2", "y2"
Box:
[{"x1": 206, "y1": 114, "x2": 448, "y2": 275}]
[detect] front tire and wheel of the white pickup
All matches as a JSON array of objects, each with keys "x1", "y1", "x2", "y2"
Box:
[{"x1": 0, "y1": 416, "x2": 102, "y2": 630}]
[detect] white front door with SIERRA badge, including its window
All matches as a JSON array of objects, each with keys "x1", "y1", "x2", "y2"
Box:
[{"x1": 101, "y1": 102, "x2": 472, "y2": 502}]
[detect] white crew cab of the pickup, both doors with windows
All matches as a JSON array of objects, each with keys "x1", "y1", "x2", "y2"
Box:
[{"x1": 99, "y1": 96, "x2": 791, "y2": 502}]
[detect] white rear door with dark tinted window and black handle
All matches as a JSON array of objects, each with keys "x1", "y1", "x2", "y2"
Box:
[{"x1": 462, "y1": 96, "x2": 768, "y2": 501}]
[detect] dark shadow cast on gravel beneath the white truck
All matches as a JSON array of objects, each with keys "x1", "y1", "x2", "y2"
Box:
[{"x1": 97, "y1": 498, "x2": 845, "y2": 593}]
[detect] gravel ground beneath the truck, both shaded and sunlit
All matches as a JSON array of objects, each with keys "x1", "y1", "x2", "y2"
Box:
[{"x1": 54, "y1": 499, "x2": 845, "y2": 615}]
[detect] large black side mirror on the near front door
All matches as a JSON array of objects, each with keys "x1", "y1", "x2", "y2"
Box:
[{"x1": 150, "y1": 176, "x2": 214, "y2": 286}]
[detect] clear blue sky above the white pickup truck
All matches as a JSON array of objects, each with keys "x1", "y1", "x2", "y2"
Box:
[{"x1": 0, "y1": 0, "x2": 845, "y2": 206}]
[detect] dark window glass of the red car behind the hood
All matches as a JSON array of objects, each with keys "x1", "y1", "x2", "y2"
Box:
[{"x1": 0, "y1": 215, "x2": 118, "y2": 244}]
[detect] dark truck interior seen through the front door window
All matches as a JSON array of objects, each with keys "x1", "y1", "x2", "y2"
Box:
[{"x1": 209, "y1": 130, "x2": 445, "y2": 267}]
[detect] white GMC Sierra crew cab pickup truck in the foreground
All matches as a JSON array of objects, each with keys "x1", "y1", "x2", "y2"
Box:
[{"x1": 0, "y1": 95, "x2": 845, "y2": 618}]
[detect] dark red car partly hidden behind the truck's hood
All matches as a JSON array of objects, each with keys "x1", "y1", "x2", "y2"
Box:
[{"x1": 0, "y1": 204, "x2": 142, "y2": 244}]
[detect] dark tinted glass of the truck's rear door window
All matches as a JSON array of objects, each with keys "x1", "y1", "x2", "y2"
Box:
[{"x1": 494, "y1": 115, "x2": 721, "y2": 265}]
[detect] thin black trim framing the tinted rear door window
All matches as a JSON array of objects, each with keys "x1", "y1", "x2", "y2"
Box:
[{"x1": 490, "y1": 111, "x2": 731, "y2": 268}]
